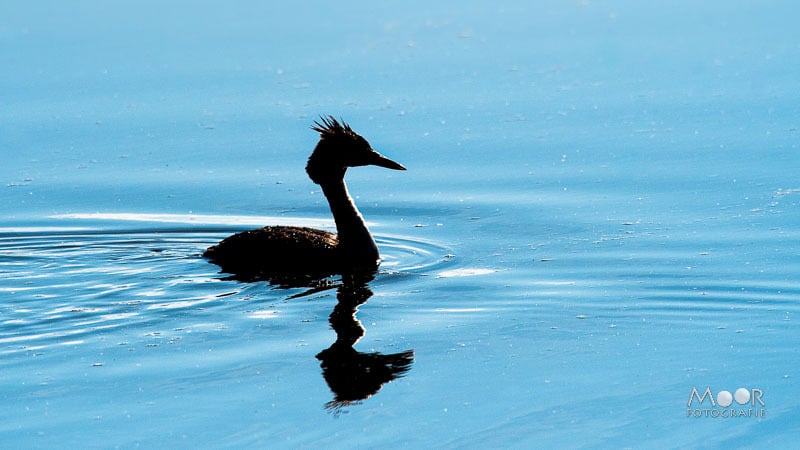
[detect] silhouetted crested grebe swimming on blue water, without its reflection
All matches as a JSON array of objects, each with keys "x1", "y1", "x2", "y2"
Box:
[{"x1": 203, "y1": 116, "x2": 406, "y2": 284}]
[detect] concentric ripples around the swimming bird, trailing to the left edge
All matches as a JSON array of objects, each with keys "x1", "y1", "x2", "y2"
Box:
[{"x1": 0, "y1": 227, "x2": 448, "y2": 354}]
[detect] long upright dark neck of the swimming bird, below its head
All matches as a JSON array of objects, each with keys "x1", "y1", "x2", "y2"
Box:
[{"x1": 320, "y1": 178, "x2": 380, "y2": 265}]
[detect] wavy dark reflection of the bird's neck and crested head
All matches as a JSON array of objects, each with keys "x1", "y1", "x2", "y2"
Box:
[{"x1": 317, "y1": 272, "x2": 414, "y2": 413}]
